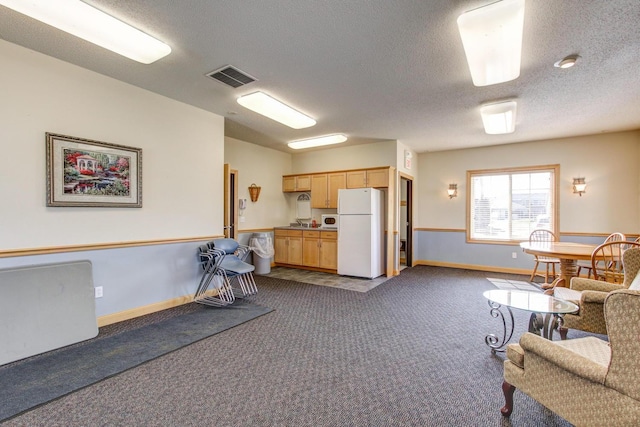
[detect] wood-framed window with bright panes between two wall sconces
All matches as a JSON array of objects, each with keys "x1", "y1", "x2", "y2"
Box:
[{"x1": 467, "y1": 165, "x2": 560, "y2": 242}]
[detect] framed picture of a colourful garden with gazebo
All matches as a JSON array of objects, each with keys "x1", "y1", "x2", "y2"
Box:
[{"x1": 46, "y1": 132, "x2": 142, "y2": 208}]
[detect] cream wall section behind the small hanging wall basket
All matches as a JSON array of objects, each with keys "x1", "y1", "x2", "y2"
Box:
[{"x1": 224, "y1": 137, "x2": 291, "y2": 232}]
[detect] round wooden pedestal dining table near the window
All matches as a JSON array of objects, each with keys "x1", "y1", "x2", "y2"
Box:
[{"x1": 520, "y1": 242, "x2": 598, "y2": 289}]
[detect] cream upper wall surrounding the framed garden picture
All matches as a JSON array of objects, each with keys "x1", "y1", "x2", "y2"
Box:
[{"x1": 0, "y1": 40, "x2": 224, "y2": 250}]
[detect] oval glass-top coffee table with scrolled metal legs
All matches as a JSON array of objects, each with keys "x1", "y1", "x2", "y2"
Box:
[{"x1": 482, "y1": 289, "x2": 578, "y2": 353}]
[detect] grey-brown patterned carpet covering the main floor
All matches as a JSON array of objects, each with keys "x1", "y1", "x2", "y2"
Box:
[{"x1": 3, "y1": 266, "x2": 577, "y2": 427}]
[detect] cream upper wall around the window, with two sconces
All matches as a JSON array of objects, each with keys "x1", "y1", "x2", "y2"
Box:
[{"x1": 415, "y1": 131, "x2": 640, "y2": 234}]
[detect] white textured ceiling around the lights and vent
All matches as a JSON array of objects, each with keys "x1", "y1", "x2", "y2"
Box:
[{"x1": 0, "y1": 0, "x2": 640, "y2": 152}]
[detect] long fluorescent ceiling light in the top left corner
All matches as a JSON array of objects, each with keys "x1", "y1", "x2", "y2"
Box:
[{"x1": 0, "y1": 0, "x2": 171, "y2": 64}]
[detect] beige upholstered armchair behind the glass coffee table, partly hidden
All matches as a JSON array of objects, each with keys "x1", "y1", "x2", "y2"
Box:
[{"x1": 554, "y1": 247, "x2": 640, "y2": 339}]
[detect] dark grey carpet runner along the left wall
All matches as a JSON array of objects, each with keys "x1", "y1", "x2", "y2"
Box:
[{"x1": 0, "y1": 301, "x2": 271, "y2": 421}]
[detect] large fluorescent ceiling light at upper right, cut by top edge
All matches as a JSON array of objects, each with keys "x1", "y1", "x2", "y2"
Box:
[{"x1": 458, "y1": 0, "x2": 524, "y2": 86}]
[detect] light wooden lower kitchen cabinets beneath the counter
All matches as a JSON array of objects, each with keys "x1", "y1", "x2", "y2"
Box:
[{"x1": 274, "y1": 229, "x2": 338, "y2": 271}]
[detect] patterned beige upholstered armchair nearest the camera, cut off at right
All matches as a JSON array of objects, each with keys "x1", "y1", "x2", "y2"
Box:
[{"x1": 501, "y1": 289, "x2": 640, "y2": 426}]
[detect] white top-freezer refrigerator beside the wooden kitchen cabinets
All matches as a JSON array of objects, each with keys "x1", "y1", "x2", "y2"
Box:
[{"x1": 338, "y1": 188, "x2": 385, "y2": 279}]
